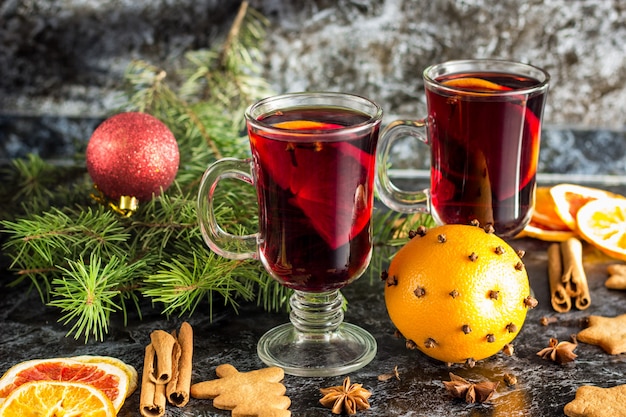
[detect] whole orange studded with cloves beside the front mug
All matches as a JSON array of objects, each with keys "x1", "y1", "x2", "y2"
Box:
[{"x1": 385, "y1": 225, "x2": 536, "y2": 364}]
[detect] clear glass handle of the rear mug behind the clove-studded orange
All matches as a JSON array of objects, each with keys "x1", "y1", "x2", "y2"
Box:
[{"x1": 376, "y1": 119, "x2": 430, "y2": 213}]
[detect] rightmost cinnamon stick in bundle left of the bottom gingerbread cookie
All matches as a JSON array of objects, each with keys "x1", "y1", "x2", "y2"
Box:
[{"x1": 166, "y1": 322, "x2": 193, "y2": 407}]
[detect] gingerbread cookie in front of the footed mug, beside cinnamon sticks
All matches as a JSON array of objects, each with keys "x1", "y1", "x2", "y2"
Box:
[{"x1": 191, "y1": 364, "x2": 291, "y2": 417}]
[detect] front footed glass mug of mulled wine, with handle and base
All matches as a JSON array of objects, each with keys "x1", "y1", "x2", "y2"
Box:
[{"x1": 198, "y1": 93, "x2": 382, "y2": 376}]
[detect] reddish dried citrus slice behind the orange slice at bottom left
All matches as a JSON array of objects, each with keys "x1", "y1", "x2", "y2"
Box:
[{"x1": 0, "y1": 358, "x2": 129, "y2": 411}]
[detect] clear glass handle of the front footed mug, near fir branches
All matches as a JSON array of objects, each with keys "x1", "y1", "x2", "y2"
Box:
[{"x1": 198, "y1": 158, "x2": 259, "y2": 259}]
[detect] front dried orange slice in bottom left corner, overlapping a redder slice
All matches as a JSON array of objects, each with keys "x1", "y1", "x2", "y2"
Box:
[{"x1": 0, "y1": 381, "x2": 116, "y2": 417}]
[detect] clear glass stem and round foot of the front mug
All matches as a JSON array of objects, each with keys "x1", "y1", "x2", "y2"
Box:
[{"x1": 257, "y1": 291, "x2": 377, "y2": 377}]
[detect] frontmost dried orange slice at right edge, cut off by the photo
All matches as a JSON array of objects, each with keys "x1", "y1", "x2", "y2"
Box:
[{"x1": 576, "y1": 198, "x2": 626, "y2": 261}]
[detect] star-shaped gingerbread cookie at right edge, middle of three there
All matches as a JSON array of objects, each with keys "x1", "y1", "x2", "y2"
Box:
[{"x1": 576, "y1": 314, "x2": 626, "y2": 355}]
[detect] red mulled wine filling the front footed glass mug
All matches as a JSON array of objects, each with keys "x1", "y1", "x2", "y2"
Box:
[{"x1": 248, "y1": 107, "x2": 378, "y2": 292}]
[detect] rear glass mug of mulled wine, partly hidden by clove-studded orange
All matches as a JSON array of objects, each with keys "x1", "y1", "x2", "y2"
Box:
[{"x1": 376, "y1": 60, "x2": 550, "y2": 238}]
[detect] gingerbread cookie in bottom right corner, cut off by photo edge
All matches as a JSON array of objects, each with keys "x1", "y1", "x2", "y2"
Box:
[{"x1": 563, "y1": 385, "x2": 626, "y2": 417}]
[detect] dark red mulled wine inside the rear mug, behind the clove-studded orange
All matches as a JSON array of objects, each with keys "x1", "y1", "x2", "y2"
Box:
[{"x1": 426, "y1": 73, "x2": 546, "y2": 236}]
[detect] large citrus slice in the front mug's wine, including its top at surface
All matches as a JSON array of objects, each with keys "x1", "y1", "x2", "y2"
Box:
[{"x1": 250, "y1": 120, "x2": 375, "y2": 249}]
